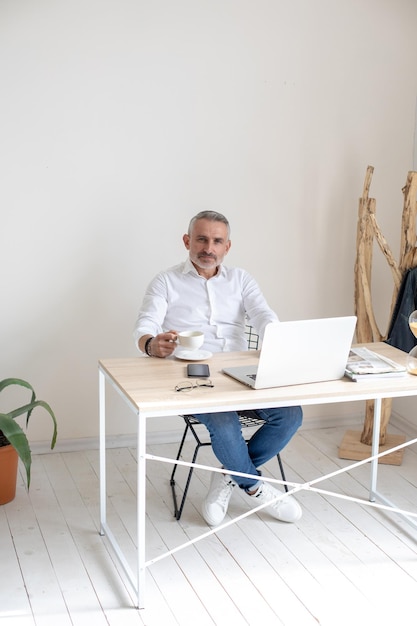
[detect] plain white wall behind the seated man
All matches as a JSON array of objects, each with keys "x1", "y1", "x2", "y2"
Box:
[{"x1": 0, "y1": 0, "x2": 417, "y2": 442}]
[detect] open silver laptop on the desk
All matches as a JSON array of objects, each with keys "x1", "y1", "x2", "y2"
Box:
[{"x1": 223, "y1": 316, "x2": 356, "y2": 389}]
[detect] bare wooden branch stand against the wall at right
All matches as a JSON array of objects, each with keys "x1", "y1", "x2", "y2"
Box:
[{"x1": 339, "y1": 166, "x2": 417, "y2": 465}]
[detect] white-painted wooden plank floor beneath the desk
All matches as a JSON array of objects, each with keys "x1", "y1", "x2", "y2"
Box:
[{"x1": 0, "y1": 424, "x2": 417, "y2": 626}]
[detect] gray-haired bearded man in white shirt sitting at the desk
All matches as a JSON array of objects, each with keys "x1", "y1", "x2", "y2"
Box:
[{"x1": 134, "y1": 211, "x2": 302, "y2": 526}]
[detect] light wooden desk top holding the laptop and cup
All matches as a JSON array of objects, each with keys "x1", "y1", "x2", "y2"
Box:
[{"x1": 99, "y1": 343, "x2": 417, "y2": 417}]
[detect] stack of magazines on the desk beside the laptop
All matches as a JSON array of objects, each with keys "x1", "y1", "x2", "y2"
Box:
[{"x1": 345, "y1": 348, "x2": 407, "y2": 381}]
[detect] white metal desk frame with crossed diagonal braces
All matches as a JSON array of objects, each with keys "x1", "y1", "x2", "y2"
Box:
[{"x1": 99, "y1": 346, "x2": 417, "y2": 608}]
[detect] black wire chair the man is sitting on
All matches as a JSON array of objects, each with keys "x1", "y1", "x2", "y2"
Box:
[{"x1": 170, "y1": 326, "x2": 288, "y2": 520}]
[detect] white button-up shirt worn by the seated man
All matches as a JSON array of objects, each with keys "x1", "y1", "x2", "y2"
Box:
[{"x1": 134, "y1": 259, "x2": 278, "y2": 352}]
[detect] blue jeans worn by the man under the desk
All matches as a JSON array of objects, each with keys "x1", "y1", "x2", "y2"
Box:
[{"x1": 196, "y1": 406, "x2": 303, "y2": 489}]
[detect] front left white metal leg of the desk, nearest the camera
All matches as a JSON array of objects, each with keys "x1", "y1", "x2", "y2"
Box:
[{"x1": 137, "y1": 413, "x2": 146, "y2": 609}]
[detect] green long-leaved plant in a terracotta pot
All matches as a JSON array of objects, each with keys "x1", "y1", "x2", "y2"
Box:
[{"x1": 0, "y1": 378, "x2": 57, "y2": 504}]
